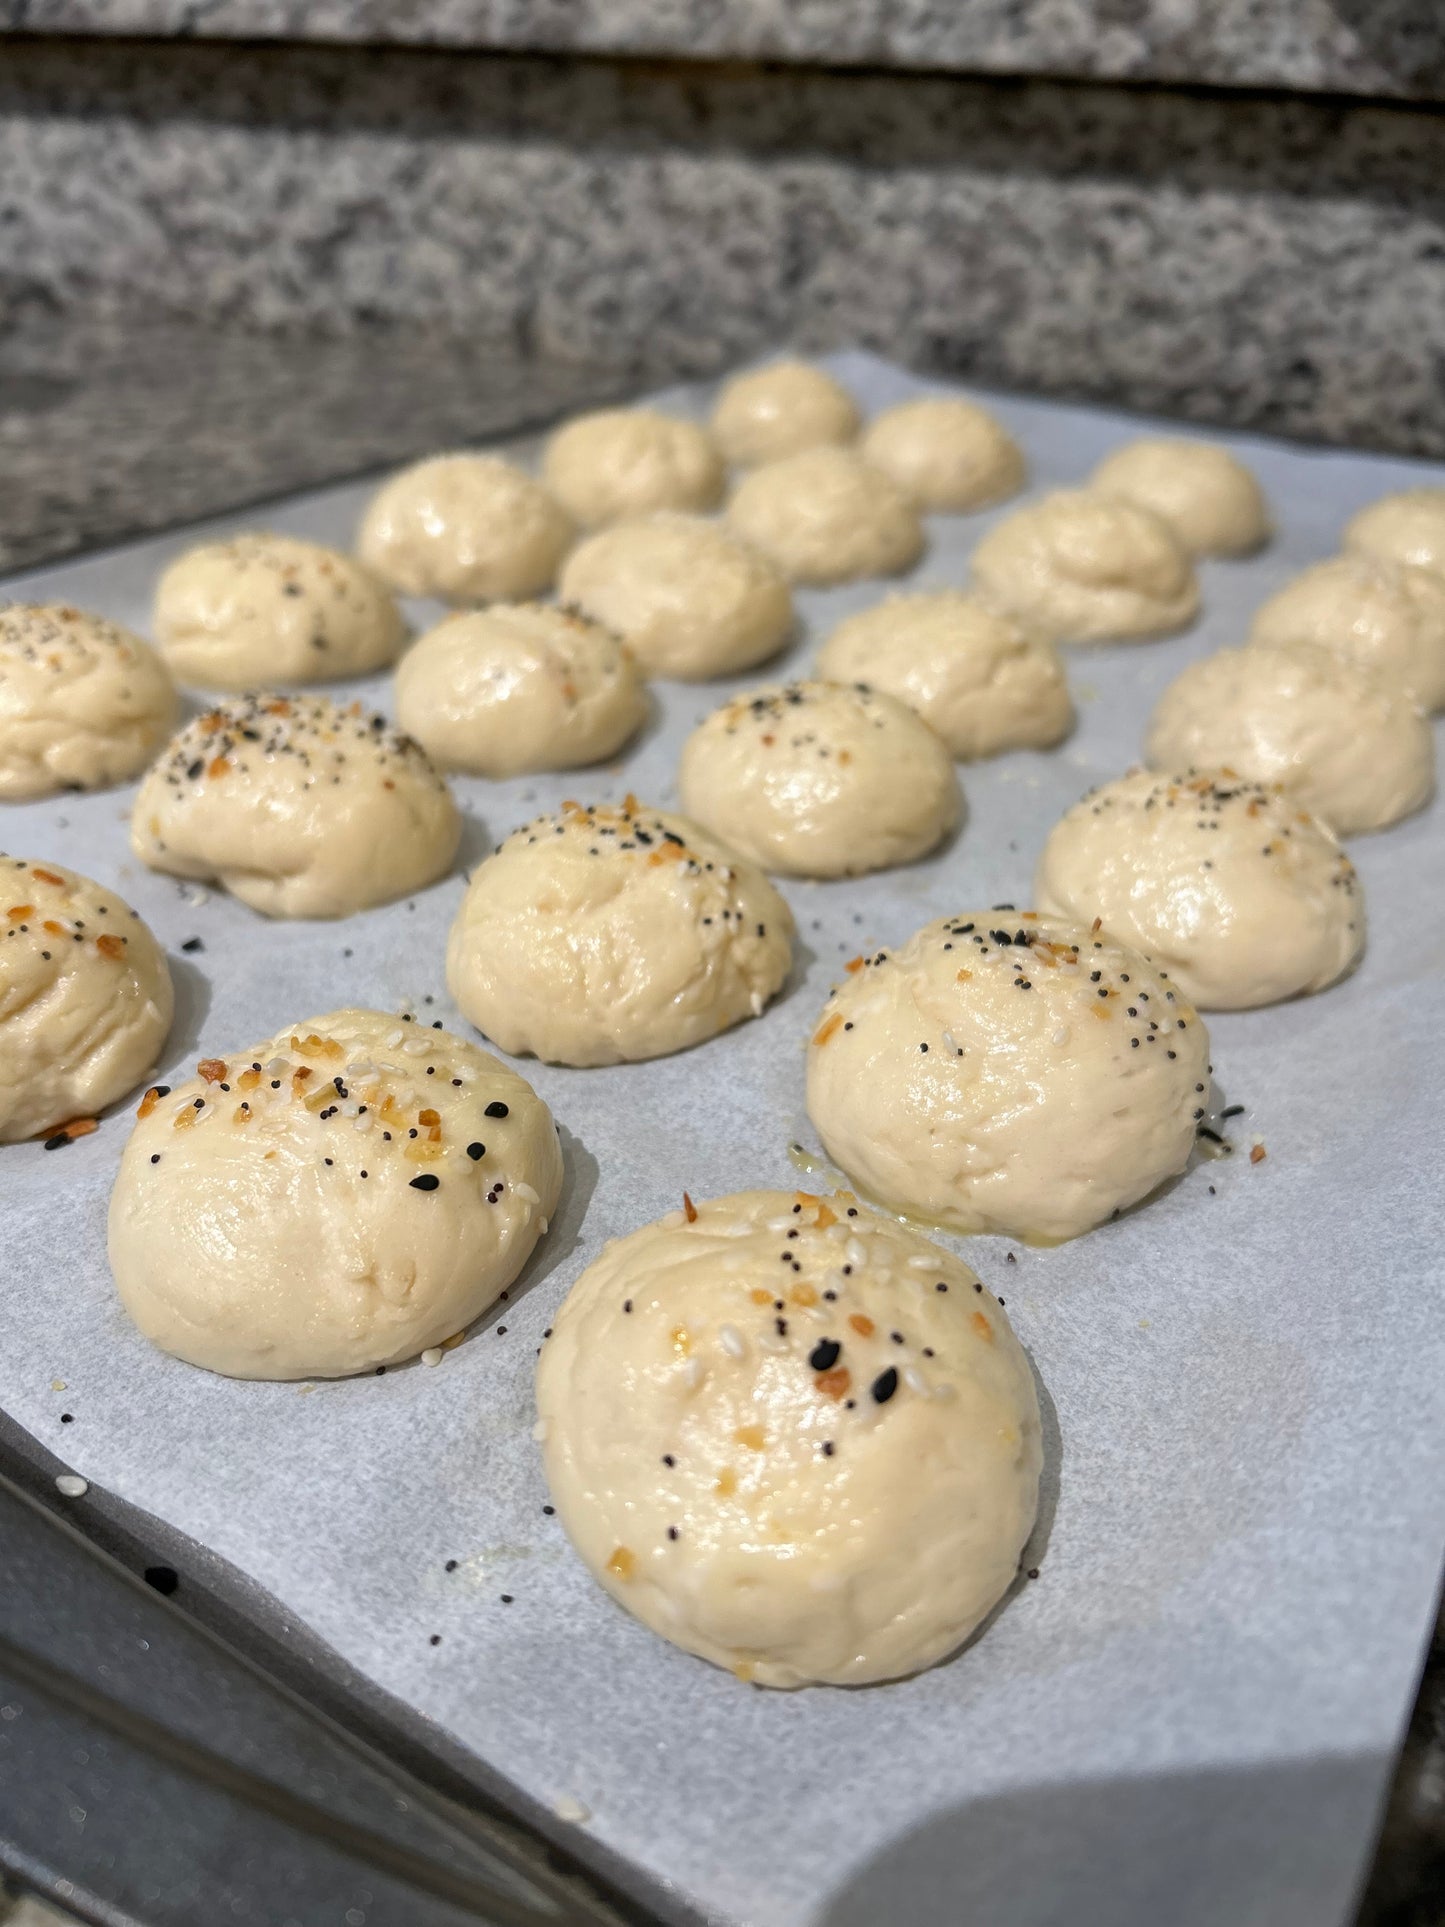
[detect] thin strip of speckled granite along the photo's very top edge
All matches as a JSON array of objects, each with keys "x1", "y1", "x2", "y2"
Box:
[{"x1": 0, "y1": 0, "x2": 1445, "y2": 96}]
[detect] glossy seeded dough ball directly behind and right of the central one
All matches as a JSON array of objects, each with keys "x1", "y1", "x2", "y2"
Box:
[{"x1": 678, "y1": 682, "x2": 963, "y2": 877}]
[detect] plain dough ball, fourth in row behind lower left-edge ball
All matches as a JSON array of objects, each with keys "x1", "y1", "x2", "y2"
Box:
[{"x1": 559, "y1": 511, "x2": 794, "y2": 682}]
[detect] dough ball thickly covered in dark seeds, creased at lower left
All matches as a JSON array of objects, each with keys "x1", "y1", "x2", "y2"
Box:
[{"x1": 131, "y1": 696, "x2": 462, "y2": 917}]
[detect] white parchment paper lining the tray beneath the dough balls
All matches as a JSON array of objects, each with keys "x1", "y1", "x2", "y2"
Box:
[{"x1": 0, "y1": 355, "x2": 1445, "y2": 1927}]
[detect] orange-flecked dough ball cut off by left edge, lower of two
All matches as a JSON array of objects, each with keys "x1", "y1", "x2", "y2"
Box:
[{"x1": 0, "y1": 856, "x2": 173, "y2": 1145}]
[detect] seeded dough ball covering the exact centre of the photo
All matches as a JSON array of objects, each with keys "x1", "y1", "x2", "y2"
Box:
[{"x1": 447, "y1": 796, "x2": 794, "y2": 1064}]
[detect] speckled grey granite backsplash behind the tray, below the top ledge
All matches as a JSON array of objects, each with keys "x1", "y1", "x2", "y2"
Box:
[{"x1": 0, "y1": 40, "x2": 1445, "y2": 481}]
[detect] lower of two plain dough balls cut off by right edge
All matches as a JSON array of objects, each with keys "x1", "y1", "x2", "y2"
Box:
[{"x1": 1248, "y1": 553, "x2": 1445, "y2": 709}]
